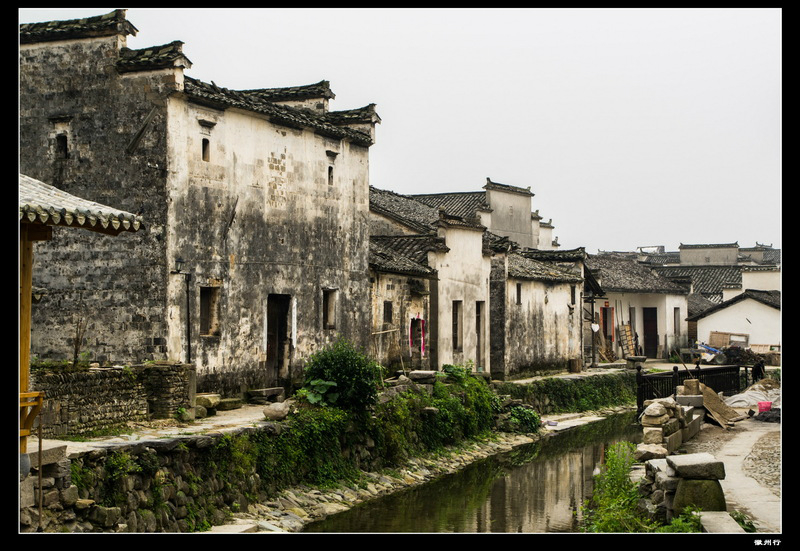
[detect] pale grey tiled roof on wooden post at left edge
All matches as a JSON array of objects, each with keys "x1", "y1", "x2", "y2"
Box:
[{"x1": 19, "y1": 174, "x2": 143, "y2": 233}]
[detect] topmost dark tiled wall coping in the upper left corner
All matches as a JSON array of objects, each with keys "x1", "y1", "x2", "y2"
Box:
[{"x1": 19, "y1": 10, "x2": 138, "y2": 44}]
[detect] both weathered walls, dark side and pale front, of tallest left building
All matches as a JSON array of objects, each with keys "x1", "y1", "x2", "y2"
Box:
[{"x1": 20, "y1": 21, "x2": 371, "y2": 395}]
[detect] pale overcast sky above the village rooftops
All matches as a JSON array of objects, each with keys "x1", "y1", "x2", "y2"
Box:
[{"x1": 19, "y1": 8, "x2": 782, "y2": 253}]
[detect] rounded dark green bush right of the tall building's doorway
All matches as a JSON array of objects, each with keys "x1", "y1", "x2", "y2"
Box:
[{"x1": 303, "y1": 340, "x2": 381, "y2": 412}]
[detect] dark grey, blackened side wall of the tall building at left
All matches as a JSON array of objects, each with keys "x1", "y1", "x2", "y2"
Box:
[{"x1": 19, "y1": 37, "x2": 175, "y2": 362}]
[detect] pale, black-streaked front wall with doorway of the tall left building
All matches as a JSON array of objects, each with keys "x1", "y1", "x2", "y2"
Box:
[{"x1": 168, "y1": 97, "x2": 370, "y2": 389}]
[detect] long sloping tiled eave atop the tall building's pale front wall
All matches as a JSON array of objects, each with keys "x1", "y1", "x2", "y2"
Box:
[{"x1": 184, "y1": 77, "x2": 372, "y2": 147}]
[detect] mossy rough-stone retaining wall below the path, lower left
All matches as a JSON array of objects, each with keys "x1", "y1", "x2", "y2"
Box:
[{"x1": 20, "y1": 433, "x2": 263, "y2": 533}]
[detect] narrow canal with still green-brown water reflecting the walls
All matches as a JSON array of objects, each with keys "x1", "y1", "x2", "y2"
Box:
[{"x1": 304, "y1": 412, "x2": 642, "y2": 533}]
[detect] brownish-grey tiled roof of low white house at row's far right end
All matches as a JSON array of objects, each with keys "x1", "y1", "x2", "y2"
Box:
[{"x1": 586, "y1": 254, "x2": 688, "y2": 295}]
